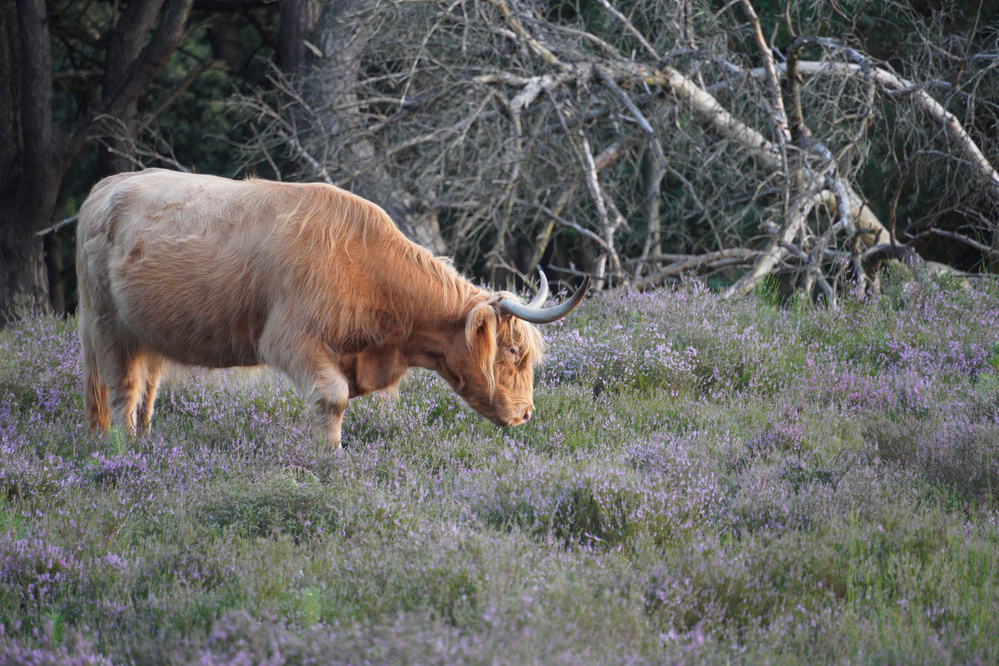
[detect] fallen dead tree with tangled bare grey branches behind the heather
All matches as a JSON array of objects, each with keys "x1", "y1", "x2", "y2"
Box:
[{"x1": 240, "y1": 0, "x2": 999, "y2": 306}]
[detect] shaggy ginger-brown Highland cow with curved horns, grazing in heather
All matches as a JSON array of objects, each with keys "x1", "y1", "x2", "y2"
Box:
[{"x1": 77, "y1": 169, "x2": 589, "y2": 446}]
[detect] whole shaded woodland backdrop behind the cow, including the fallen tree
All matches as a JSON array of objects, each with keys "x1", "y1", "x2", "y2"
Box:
[{"x1": 0, "y1": 0, "x2": 999, "y2": 322}]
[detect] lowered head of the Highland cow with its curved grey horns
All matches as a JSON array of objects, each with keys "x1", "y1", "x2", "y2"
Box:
[{"x1": 438, "y1": 273, "x2": 590, "y2": 426}]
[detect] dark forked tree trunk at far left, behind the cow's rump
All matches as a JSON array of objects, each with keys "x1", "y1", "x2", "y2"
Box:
[{"x1": 0, "y1": 0, "x2": 193, "y2": 323}]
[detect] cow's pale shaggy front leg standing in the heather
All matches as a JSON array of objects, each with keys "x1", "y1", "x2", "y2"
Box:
[{"x1": 260, "y1": 331, "x2": 350, "y2": 449}]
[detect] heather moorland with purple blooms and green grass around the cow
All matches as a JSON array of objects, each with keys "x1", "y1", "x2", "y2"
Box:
[{"x1": 0, "y1": 268, "x2": 999, "y2": 664}]
